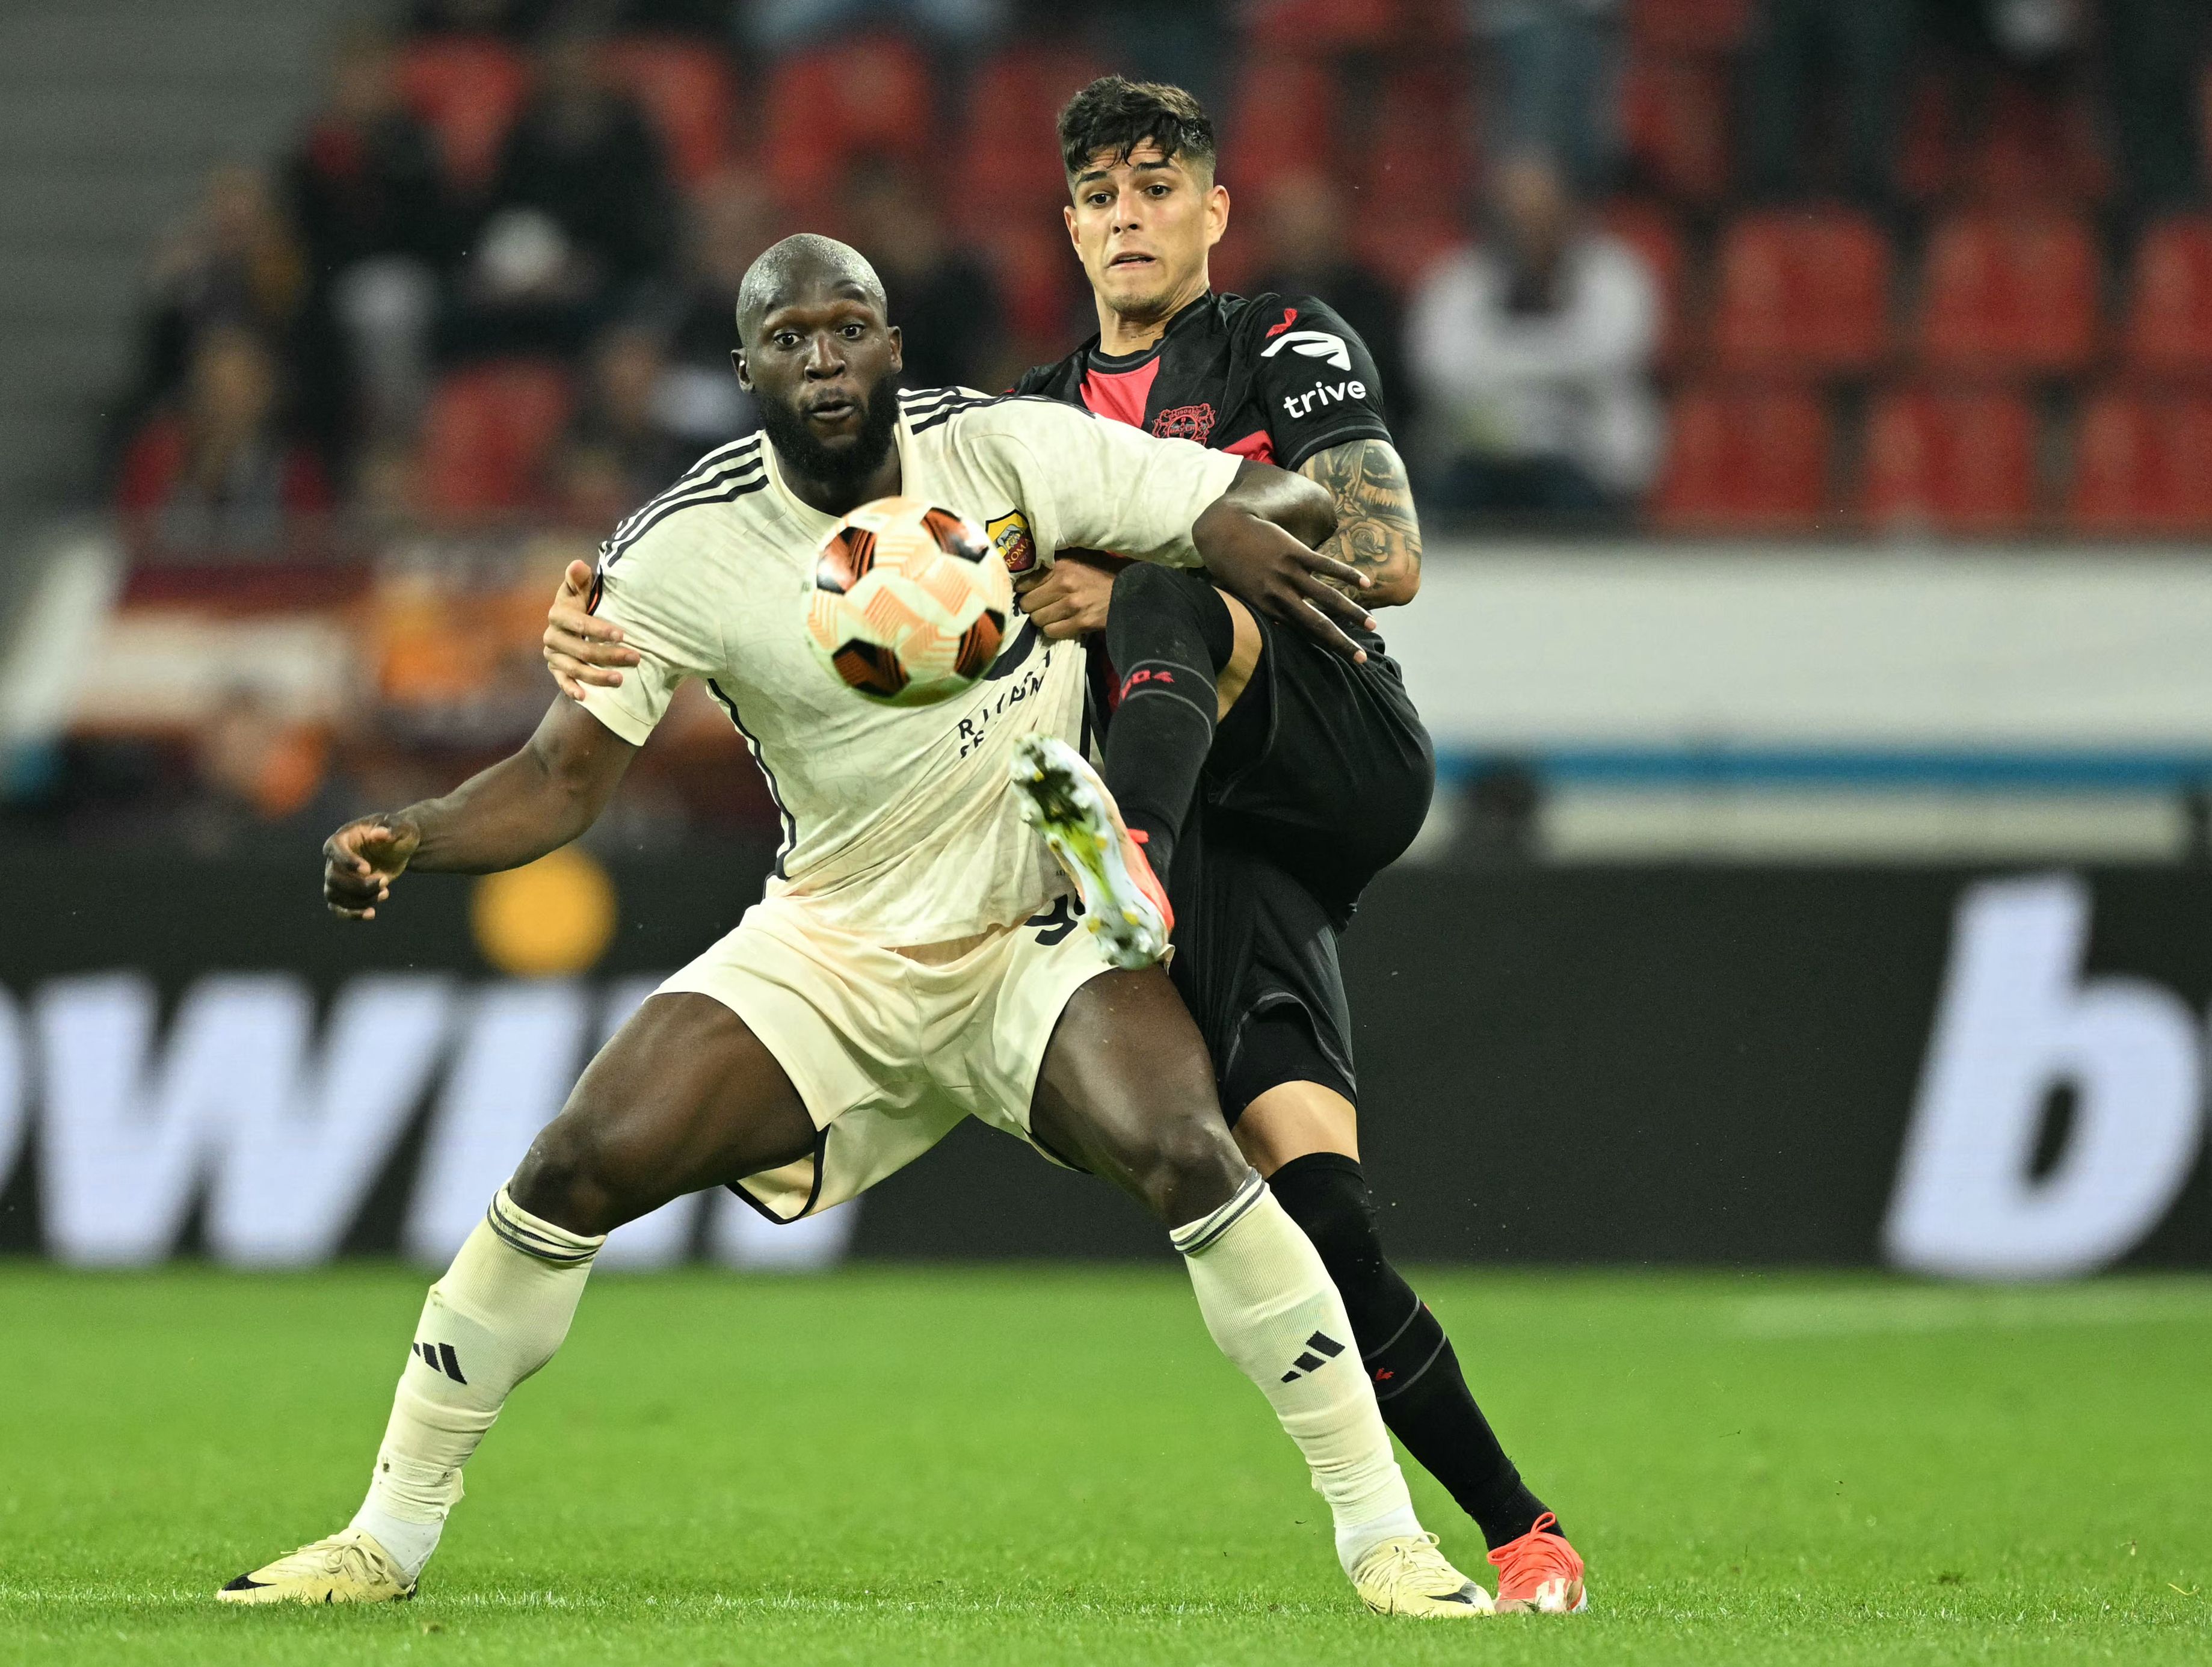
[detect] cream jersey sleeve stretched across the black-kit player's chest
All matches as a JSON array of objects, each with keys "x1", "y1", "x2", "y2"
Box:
[{"x1": 976, "y1": 398, "x2": 1243, "y2": 568}]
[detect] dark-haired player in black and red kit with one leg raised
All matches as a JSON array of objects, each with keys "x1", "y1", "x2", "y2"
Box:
[{"x1": 546, "y1": 78, "x2": 1586, "y2": 1612}]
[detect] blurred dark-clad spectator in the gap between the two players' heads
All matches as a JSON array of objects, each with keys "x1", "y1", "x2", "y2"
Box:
[{"x1": 847, "y1": 166, "x2": 1020, "y2": 387}]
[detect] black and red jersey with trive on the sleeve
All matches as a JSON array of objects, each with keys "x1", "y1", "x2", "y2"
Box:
[{"x1": 1013, "y1": 294, "x2": 1389, "y2": 469}]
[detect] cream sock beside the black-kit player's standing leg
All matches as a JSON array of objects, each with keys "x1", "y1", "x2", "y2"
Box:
[{"x1": 1170, "y1": 1169, "x2": 1420, "y2": 1574}]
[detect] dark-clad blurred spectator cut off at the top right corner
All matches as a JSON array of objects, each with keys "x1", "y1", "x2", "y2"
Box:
[{"x1": 2104, "y1": 0, "x2": 2212, "y2": 212}]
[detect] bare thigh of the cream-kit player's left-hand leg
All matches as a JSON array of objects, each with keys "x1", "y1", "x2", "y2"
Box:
[{"x1": 511, "y1": 990, "x2": 814, "y2": 1234}]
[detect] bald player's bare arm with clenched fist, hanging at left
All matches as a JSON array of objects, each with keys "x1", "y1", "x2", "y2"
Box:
[{"x1": 323, "y1": 701, "x2": 637, "y2": 920}]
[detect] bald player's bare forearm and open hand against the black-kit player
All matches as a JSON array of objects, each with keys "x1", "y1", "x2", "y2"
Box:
[{"x1": 1190, "y1": 460, "x2": 1376, "y2": 661}]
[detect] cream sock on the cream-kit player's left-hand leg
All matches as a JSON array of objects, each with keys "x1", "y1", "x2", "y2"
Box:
[{"x1": 352, "y1": 1188, "x2": 606, "y2": 1579}]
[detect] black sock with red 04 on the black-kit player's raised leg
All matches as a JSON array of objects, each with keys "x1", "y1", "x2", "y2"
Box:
[{"x1": 1106, "y1": 561, "x2": 1234, "y2": 884}]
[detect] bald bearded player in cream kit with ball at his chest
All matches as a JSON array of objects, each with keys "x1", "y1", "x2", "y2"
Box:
[{"x1": 221, "y1": 236, "x2": 1491, "y2": 1616}]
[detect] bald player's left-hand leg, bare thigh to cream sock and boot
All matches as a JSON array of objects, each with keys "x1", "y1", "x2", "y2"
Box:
[{"x1": 219, "y1": 993, "x2": 814, "y2": 1603}]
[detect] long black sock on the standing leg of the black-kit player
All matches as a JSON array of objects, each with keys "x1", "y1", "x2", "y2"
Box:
[{"x1": 1268, "y1": 1152, "x2": 1564, "y2": 1550}]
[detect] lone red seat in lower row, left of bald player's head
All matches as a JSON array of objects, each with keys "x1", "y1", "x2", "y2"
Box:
[{"x1": 422, "y1": 358, "x2": 568, "y2": 520}]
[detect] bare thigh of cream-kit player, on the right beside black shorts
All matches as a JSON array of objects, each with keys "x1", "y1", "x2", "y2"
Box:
[{"x1": 1029, "y1": 966, "x2": 1248, "y2": 1227}]
